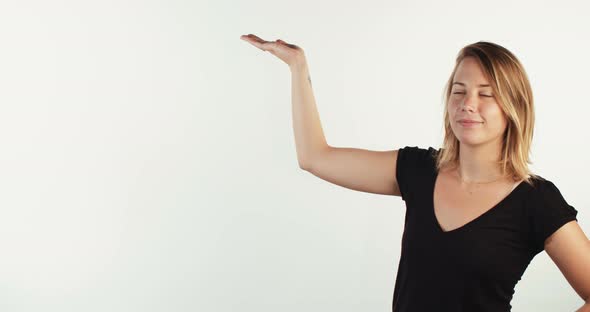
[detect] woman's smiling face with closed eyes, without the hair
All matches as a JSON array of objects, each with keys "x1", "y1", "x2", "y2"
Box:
[{"x1": 447, "y1": 57, "x2": 507, "y2": 146}]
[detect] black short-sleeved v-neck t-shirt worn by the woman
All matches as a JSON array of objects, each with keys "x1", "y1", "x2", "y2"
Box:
[{"x1": 392, "y1": 146, "x2": 577, "y2": 312}]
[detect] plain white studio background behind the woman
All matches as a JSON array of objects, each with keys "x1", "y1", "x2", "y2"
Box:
[{"x1": 0, "y1": 0, "x2": 590, "y2": 312}]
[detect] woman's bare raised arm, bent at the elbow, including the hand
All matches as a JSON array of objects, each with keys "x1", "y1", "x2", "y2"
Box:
[{"x1": 241, "y1": 34, "x2": 401, "y2": 196}]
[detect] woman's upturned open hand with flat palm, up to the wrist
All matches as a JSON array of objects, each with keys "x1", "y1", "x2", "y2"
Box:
[{"x1": 240, "y1": 34, "x2": 306, "y2": 69}]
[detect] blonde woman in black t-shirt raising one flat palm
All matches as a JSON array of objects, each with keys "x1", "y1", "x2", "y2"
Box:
[{"x1": 241, "y1": 35, "x2": 590, "y2": 312}]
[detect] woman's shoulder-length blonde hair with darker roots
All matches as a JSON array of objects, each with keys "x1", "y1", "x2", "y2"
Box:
[{"x1": 436, "y1": 41, "x2": 538, "y2": 185}]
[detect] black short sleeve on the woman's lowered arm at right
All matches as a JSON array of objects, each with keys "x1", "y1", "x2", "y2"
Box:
[{"x1": 530, "y1": 180, "x2": 578, "y2": 254}]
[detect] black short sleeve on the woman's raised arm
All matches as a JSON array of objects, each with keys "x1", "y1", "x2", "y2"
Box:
[{"x1": 395, "y1": 146, "x2": 436, "y2": 201}]
